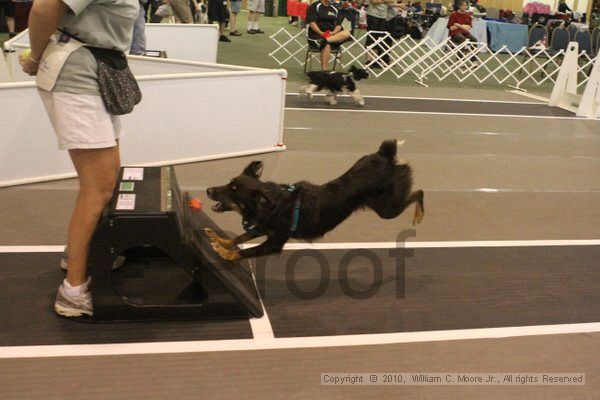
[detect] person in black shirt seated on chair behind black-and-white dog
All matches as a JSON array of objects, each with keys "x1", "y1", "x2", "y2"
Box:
[{"x1": 306, "y1": 0, "x2": 350, "y2": 71}]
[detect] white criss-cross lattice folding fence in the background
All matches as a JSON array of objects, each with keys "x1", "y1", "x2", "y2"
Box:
[{"x1": 269, "y1": 28, "x2": 595, "y2": 89}]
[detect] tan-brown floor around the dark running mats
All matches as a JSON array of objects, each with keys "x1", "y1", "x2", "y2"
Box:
[{"x1": 0, "y1": 85, "x2": 600, "y2": 400}]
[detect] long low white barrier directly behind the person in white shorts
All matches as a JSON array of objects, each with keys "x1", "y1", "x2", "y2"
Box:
[{"x1": 0, "y1": 57, "x2": 286, "y2": 187}]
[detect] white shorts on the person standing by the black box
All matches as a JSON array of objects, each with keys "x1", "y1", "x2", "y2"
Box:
[{"x1": 38, "y1": 90, "x2": 123, "y2": 150}]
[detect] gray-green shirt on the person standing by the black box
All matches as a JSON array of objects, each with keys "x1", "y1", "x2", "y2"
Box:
[{"x1": 54, "y1": 0, "x2": 140, "y2": 96}]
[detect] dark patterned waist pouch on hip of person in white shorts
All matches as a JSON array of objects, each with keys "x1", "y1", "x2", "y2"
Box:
[{"x1": 85, "y1": 46, "x2": 142, "y2": 115}]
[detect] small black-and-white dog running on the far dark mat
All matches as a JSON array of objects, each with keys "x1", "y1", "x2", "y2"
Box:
[{"x1": 300, "y1": 65, "x2": 369, "y2": 106}]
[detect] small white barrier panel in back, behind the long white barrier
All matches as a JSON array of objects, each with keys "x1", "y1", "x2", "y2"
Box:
[{"x1": 146, "y1": 24, "x2": 219, "y2": 63}]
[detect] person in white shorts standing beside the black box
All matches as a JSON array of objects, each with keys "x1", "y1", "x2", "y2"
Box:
[{"x1": 20, "y1": 0, "x2": 140, "y2": 317}]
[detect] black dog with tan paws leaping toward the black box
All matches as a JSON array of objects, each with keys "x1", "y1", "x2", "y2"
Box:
[{"x1": 205, "y1": 140, "x2": 424, "y2": 260}]
